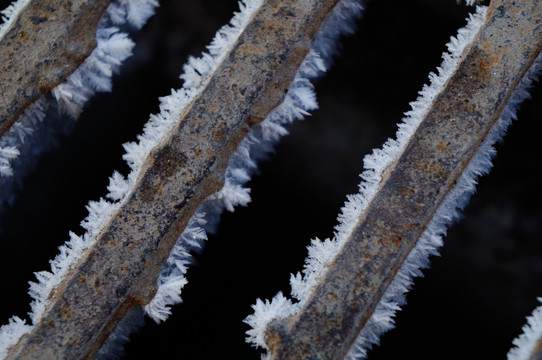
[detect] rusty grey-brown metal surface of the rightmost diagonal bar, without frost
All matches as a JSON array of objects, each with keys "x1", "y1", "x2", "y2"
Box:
[{"x1": 267, "y1": 0, "x2": 542, "y2": 360}]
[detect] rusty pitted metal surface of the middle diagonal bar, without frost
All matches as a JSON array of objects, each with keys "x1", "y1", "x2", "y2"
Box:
[{"x1": 4, "y1": 0, "x2": 342, "y2": 359}]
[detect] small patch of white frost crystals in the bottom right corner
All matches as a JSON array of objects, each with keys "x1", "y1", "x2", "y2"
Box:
[{"x1": 507, "y1": 298, "x2": 542, "y2": 360}]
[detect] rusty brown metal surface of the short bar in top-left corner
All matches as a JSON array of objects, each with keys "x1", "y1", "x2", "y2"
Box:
[{"x1": 0, "y1": 0, "x2": 111, "y2": 136}]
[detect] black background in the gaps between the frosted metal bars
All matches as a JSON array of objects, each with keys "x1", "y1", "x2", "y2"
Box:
[{"x1": 0, "y1": 0, "x2": 542, "y2": 359}]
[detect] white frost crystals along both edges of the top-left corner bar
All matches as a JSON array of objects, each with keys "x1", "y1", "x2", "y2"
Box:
[{"x1": 0, "y1": 0, "x2": 158, "y2": 179}]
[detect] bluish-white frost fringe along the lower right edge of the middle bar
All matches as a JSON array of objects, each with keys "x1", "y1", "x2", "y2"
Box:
[{"x1": 145, "y1": 0, "x2": 362, "y2": 322}]
